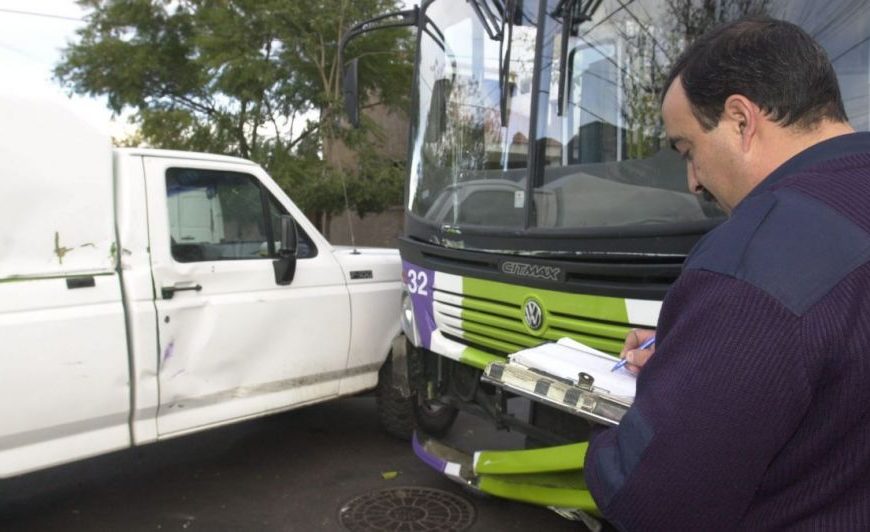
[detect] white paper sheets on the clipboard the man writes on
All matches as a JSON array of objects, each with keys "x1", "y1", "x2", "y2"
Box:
[{"x1": 508, "y1": 338, "x2": 637, "y2": 398}]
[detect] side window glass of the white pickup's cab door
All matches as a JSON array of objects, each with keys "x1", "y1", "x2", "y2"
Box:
[{"x1": 166, "y1": 168, "x2": 316, "y2": 262}]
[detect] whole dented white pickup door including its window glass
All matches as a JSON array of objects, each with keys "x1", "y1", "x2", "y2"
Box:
[{"x1": 144, "y1": 157, "x2": 350, "y2": 436}]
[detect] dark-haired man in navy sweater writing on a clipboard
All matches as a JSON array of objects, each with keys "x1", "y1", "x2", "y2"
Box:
[{"x1": 585, "y1": 19, "x2": 870, "y2": 531}]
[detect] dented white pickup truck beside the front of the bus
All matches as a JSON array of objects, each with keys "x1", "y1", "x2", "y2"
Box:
[{"x1": 0, "y1": 97, "x2": 403, "y2": 478}]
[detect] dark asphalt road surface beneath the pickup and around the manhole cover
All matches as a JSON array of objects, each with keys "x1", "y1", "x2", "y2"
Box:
[{"x1": 0, "y1": 396, "x2": 585, "y2": 531}]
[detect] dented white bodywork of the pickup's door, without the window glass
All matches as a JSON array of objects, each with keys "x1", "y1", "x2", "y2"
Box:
[{"x1": 143, "y1": 156, "x2": 354, "y2": 437}]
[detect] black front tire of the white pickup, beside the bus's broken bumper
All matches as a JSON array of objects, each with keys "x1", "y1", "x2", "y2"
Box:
[{"x1": 376, "y1": 361, "x2": 458, "y2": 440}]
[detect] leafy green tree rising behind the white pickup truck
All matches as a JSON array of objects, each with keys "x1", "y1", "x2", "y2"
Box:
[{"x1": 55, "y1": 0, "x2": 412, "y2": 233}]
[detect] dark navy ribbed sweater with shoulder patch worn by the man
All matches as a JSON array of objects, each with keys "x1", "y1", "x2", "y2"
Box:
[{"x1": 585, "y1": 133, "x2": 870, "y2": 531}]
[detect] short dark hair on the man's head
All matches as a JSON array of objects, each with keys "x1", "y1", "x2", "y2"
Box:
[{"x1": 662, "y1": 17, "x2": 848, "y2": 131}]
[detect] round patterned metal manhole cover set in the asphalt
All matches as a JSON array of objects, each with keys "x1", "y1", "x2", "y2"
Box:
[{"x1": 338, "y1": 488, "x2": 474, "y2": 532}]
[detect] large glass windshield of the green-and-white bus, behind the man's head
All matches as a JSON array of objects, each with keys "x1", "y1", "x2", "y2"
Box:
[{"x1": 407, "y1": 0, "x2": 870, "y2": 243}]
